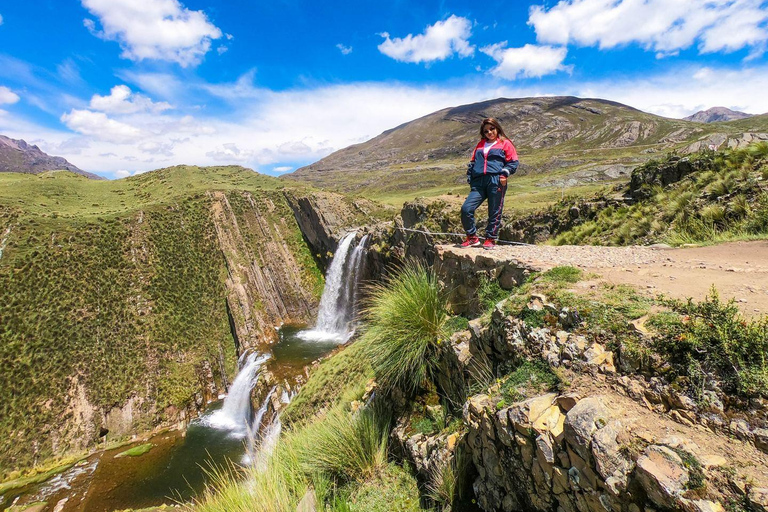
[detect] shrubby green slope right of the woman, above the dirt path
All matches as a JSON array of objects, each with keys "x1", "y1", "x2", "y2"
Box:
[{"x1": 553, "y1": 142, "x2": 768, "y2": 245}]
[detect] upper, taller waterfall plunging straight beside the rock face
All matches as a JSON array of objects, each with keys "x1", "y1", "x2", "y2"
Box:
[{"x1": 297, "y1": 232, "x2": 368, "y2": 342}]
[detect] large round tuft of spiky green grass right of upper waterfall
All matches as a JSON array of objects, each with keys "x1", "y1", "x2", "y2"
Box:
[{"x1": 359, "y1": 263, "x2": 448, "y2": 393}]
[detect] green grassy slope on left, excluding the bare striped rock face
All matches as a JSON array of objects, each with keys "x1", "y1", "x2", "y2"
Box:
[{"x1": 0, "y1": 166, "x2": 321, "y2": 469}]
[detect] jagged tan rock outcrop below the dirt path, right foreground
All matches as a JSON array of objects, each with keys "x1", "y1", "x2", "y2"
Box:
[{"x1": 393, "y1": 246, "x2": 768, "y2": 512}]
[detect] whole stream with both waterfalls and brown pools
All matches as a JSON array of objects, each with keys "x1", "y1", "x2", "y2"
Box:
[{"x1": 0, "y1": 232, "x2": 368, "y2": 512}]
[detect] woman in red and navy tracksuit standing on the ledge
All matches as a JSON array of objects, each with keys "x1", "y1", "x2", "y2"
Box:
[{"x1": 461, "y1": 117, "x2": 518, "y2": 249}]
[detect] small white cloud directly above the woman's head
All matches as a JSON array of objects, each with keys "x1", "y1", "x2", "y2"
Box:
[{"x1": 480, "y1": 41, "x2": 568, "y2": 80}]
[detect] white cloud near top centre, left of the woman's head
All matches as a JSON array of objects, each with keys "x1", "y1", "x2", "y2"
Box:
[{"x1": 379, "y1": 15, "x2": 475, "y2": 63}]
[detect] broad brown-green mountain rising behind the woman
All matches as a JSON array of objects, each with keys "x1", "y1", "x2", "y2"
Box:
[{"x1": 283, "y1": 97, "x2": 768, "y2": 203}]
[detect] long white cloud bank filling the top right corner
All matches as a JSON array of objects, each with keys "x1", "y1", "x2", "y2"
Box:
[{"x1": 528, "y1": 0, "x2": 768, "y2": 55}]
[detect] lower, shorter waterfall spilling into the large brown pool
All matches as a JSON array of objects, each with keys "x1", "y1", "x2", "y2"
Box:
[{"x1": 202, "y1": 354, "x2": 270, "y2": 437}]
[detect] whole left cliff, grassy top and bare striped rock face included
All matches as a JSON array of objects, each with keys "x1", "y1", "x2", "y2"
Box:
[{"x1": 0, "y1": 168, "x2": 323, "y2": 470}]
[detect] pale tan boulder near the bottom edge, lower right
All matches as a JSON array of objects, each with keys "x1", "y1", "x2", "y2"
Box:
[{"x1": 636, "y1": 445, "x2": 688, "y2": 509}]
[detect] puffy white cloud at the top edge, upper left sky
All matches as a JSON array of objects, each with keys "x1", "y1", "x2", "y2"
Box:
[{"x1": 82, "y1": 0, "x2": 222, "y2": 67}]
